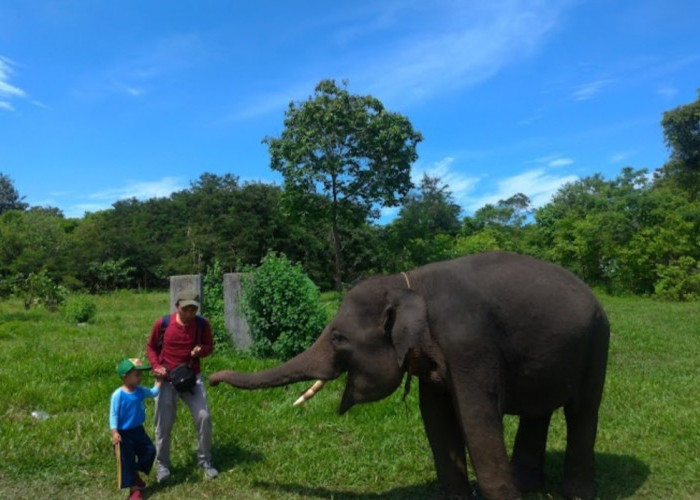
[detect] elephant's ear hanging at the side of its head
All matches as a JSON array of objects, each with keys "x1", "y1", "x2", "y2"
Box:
[{"x1": 382, "y1": 289, "x2": 429, "y2": 366}]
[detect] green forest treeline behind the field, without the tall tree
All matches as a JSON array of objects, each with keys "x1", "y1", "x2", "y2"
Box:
[{"x1": 0, "y1": 88, "x2": 700, "y2": 300}]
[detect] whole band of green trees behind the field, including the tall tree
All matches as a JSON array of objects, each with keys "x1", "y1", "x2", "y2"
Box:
[{"x1": 0, "y1": 94, "x2": 700, "y2": 304}]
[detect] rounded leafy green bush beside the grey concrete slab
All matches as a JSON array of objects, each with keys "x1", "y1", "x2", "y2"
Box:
[{"x1": 241, "y1": 252, "x2": 326, "y2": 359}]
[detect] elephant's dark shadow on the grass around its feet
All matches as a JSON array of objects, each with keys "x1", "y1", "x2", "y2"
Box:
[{"x1": 249, "y1": 451, "x2": 650, "y2": 500}]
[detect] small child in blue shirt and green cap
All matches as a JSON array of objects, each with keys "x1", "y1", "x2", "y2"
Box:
[{"x1": 109, "y1": 358, "x2": 161, "y2": 500}]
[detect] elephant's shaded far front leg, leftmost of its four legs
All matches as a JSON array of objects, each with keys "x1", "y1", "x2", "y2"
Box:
[{"x1": 419, "y1": 380, "x2": 472, "y2": 498}]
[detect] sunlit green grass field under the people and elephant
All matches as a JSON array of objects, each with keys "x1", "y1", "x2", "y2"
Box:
[{"x1": 0, "y1": 292, "x2": 700, "y2": 500}]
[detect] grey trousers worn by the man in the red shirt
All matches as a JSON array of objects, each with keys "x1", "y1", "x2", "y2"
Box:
[{"x1": 155, "y1": 373, "x2": 211, "y2": 469}]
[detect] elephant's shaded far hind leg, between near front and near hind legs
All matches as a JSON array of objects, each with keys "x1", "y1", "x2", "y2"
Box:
[{"x1": 511, "y1": 413, "x2": 552, "y2": 492}]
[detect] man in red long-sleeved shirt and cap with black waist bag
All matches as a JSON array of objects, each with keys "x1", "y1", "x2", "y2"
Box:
[{"x1": 146, "y1": 290, "x2": 219, "y2": 483}]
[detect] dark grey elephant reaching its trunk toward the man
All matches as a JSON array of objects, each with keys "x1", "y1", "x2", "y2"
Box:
[{"x1": 209, "y1": 251, "x2": 610, "y2": 500}]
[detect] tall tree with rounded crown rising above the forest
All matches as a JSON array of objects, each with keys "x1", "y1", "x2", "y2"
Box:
[{"x1": 263, "y1": 80, "x2": 423, "y2": 290}]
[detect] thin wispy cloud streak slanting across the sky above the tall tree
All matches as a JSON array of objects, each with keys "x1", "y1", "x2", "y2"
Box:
[{"x1": 228, "y1": 0, "x2": 573, "y2": 120}]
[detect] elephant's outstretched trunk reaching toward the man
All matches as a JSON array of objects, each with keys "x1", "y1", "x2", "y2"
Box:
[{"x1": 209, "y1": 331, "x2": 341, "y2": 390}]
